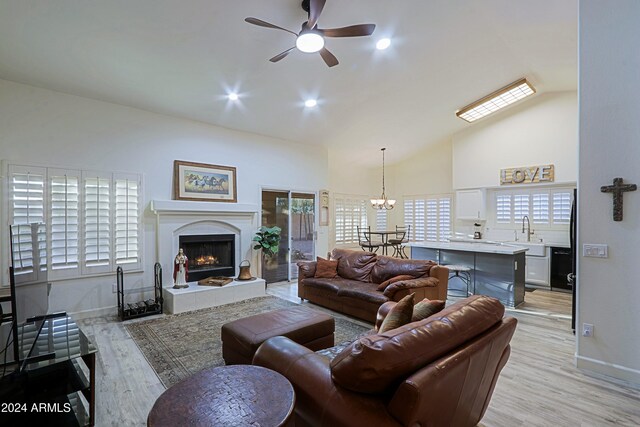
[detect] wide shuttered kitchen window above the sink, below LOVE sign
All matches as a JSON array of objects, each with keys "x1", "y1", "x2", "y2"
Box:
[{"x1": 495, "y1": 187, "x2": 572, "y2": 226}]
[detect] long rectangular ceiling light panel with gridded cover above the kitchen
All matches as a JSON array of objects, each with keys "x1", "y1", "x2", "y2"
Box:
[{"x1": 456, "y1": 79, "x2": 536, "y2": 123}]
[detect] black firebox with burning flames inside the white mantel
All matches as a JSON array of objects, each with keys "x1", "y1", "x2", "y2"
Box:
[{"x1": 179, "y1": 234, "x2": 236, "y2": 282}]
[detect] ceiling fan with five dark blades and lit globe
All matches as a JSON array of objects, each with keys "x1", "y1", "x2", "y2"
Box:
[{"x1": 245, "y1": 0, "x2": 376, "y2": 67}]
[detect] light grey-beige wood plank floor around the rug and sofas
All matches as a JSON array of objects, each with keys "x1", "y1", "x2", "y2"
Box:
[{"x1": 79, "y1": 283, "x2": 640, "y2": 427}]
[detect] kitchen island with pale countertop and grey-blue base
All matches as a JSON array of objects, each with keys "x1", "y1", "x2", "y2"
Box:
[{"x1": 408, "y1": 241, "x2": 528, "y2": 307}]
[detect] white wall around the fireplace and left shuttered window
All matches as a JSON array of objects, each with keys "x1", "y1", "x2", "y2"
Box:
[{"x1": 0, "y1": 80, "x2": 328, "y2": 312}]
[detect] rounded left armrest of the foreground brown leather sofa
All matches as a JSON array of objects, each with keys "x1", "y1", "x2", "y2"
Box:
[{"x1": 253, "y1": 336, "x2": 400, "y2": 427}]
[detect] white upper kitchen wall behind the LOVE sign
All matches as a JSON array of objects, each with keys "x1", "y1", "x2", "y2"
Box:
[{"x1": 453, "y1": 92, "x2": 578, "y2": 189}]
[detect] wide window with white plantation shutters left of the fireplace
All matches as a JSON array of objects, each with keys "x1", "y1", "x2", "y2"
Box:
[{"x1": 9, "y1": 165, "x2": 142, "y2": 279}]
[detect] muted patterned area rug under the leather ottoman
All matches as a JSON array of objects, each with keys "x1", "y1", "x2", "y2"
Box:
[{"x1": 125, "y1": 296, "x2": 367, "y2": 388}]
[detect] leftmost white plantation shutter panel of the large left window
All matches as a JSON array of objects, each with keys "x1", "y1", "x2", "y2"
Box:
[{"x1": 9, "y1": 166, "x2": 47, "y2": 281}]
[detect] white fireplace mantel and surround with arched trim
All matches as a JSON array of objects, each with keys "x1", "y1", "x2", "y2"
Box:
[{"x1": 149, "y1": 200, "x2": 258, "y2": 286}]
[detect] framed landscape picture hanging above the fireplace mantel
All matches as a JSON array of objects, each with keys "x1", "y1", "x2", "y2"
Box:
[{"x1": 173, "y1": 160, "x2": 237, "y2": 203}]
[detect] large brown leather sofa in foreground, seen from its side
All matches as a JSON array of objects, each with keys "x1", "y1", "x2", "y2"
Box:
[{"x1": 253, "y1": 295, "x2": 516, "y2": 427}]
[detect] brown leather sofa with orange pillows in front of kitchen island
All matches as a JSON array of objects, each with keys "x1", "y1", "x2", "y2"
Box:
[{"x1": 298, "y1": 249, "x2": 449, "y2": 323}]
